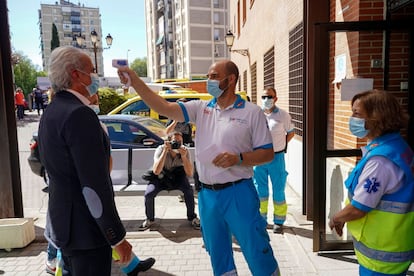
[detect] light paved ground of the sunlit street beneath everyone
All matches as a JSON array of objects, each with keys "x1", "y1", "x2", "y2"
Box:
[{"x1": 0, "y1": 112, "x2": 414, "y2": 276}]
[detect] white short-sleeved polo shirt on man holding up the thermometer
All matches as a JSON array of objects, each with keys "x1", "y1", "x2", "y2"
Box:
[{"x1": 179, "y1": 95, "x2": 272, "y2": 184}]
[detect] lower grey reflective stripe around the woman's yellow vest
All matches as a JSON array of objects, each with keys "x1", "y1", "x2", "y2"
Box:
[{"x1": 353, "y1": 239, "x2": 414, "y2": 263}]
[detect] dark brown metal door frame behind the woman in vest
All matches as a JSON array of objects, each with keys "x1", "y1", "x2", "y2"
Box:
[{"x1": 304, "y1": 19, "x2": 414, "y2": 252}]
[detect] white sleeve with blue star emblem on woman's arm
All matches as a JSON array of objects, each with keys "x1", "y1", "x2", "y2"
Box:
[{"x1": 351, "y1": 148, "x2": 404, "y2": 212}]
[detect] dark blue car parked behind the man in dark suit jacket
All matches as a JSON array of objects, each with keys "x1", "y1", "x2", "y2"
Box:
[{"x1": 28, "y1": 115, "x2": 167, "y2": 184}]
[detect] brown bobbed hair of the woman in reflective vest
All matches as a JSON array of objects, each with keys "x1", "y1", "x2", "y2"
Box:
[{"x1": 351, "y1": 89, "x2": 408, "y2": 137}]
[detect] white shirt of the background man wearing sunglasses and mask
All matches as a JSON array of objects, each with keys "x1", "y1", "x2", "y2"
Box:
[{"x1": 265, "y1": 107, "x2": 294, "y2": 152}]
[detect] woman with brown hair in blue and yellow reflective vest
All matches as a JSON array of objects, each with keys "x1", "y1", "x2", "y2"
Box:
[{"x1": 329, "y1": 90, "x2": 414, "y2": 276}]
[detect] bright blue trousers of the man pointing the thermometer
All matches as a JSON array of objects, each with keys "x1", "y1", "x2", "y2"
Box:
[{"x1": 198, "y1": 179, "x2": 278, "y2": 276}]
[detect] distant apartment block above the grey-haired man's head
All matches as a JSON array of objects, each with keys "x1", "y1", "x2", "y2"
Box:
[{"x1": 39, "y1": 0, "x2": 104, "y2": 76}]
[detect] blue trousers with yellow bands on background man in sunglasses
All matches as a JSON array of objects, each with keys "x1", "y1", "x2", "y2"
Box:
[{"x1": 253, "y1": 152, "x2": 288, "y2": 224}]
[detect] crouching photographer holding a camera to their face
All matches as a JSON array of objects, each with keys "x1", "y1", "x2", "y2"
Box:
[{"x1": 138, "y1": 132, "x2": 200, "y2": 231}]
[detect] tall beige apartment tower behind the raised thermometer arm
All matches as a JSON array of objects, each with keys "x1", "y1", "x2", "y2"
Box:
[{"x1": 145, "y1": 0, "x2": 229, "y2": 80}]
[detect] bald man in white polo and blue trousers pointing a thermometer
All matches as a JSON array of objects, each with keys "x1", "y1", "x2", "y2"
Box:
[{"x1": 118, "y1": 60, "x2": 279, "y2": 276}]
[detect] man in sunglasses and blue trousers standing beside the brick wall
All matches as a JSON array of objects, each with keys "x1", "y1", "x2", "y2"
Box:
[{"x1": 253, "y1": 87, "x2": 295, "y2": 234}]
